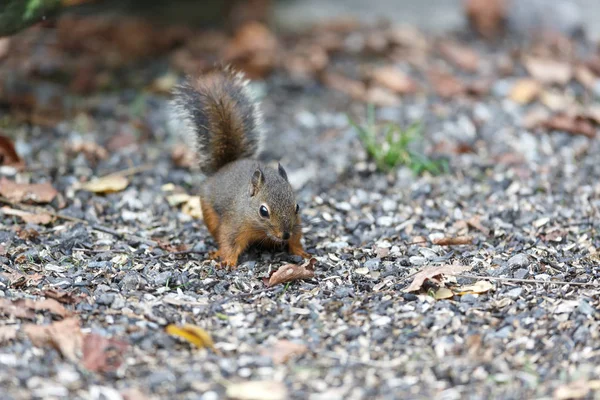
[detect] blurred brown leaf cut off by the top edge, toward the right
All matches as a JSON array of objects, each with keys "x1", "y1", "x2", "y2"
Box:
[{"x1": 464, "y1": 0, "x2": 508, "y2": 39}]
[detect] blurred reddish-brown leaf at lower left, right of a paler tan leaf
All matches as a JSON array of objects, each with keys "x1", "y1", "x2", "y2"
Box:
[{"x1": 82, "y1": 333, "x2": 128, "y2": 372}]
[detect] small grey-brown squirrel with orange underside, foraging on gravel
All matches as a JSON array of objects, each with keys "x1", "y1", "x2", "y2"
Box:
[{"x1": 173, "y1": 67, "x2": 310, "y2": 268}]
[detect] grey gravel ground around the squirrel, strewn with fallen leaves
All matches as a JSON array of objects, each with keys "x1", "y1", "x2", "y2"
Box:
[{"x1": 0, "y1": 7, "x2": 600, "y2": 400}]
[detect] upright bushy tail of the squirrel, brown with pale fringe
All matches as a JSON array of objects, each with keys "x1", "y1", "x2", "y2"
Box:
[{"x1": 173, "y1": 67, "x2": 263, "y2": 175}]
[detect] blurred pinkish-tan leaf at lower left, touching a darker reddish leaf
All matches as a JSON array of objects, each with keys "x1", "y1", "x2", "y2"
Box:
[{"x1": 23, "y1": 317, "x2": 83, "y2": 362}]
